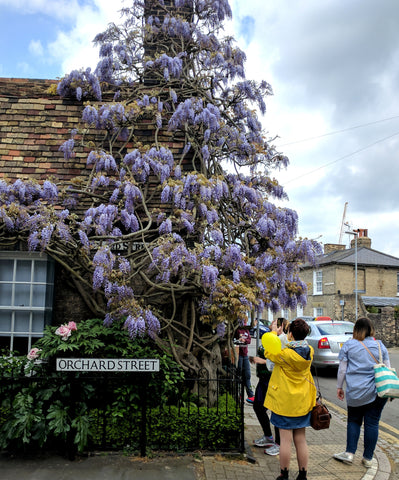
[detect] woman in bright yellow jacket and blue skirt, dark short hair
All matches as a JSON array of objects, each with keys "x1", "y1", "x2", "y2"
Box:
[{"x1": 265, "y1": 318, "x2": 316, "y2": 480}]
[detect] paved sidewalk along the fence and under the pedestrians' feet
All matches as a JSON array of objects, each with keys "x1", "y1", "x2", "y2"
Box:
[{"x1": 0, "y1": 402, "x2": 394, "y2": 480}]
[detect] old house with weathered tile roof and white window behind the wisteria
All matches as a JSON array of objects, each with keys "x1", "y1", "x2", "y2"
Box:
[{"x1": 0, "y1": 78, "x2": 191, "y2": 353}]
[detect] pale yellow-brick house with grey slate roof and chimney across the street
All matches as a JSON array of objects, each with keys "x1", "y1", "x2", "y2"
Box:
[{"x1": 294, "y1": 229, "x2": 399, "y2": 340}]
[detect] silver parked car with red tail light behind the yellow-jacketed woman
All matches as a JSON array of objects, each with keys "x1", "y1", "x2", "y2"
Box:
[{"x1": 301, "y1": 317, "x2": 354, "y2": 368}]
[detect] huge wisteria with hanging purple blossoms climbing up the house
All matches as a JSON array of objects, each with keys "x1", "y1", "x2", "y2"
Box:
[{"x1": 0, "y1": 0, "x2": 320, "y2": 376}]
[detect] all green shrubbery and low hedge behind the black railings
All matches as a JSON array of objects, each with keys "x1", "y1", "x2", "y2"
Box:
[{"x1": 0, "y1": 319, "x2": 240, "y2": 452}]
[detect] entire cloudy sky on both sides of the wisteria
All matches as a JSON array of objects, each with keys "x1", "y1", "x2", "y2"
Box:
[{"x1": 0, "y1": 0, "x2": 399, "y2": 257}]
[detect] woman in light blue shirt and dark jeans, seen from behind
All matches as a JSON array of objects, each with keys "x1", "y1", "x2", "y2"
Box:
[{"x1": 334, "y1": 317, "x2": 390, "y2": 468}]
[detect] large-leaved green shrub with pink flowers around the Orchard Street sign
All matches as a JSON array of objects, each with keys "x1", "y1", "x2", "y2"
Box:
[{"x1": 0, "y1": 319, "x2": 183, "y2": 451}]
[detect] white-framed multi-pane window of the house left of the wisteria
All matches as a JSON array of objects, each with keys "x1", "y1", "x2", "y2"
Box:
[{"x1": 0, "y1": 252, "x2": 54, "y2": 354}]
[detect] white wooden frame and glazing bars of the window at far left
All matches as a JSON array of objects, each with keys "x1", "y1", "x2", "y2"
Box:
[{"x1": 0, "y1": 251, "x2": 54, "y2": 353}]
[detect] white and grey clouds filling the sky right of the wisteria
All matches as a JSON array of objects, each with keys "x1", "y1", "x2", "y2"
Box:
[{"x1": 228, "y1": 0, "x2": 399, "y2": 256}]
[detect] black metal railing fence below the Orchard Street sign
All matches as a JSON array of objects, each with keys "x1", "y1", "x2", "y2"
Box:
[{"x1": 0, "y1": 368, "x2": 244, "y2": 458}]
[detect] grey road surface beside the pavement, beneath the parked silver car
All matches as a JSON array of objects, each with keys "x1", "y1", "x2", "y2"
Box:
[{"x1": 317, "y1": 348, "x2": 399, "y2": 441}]
